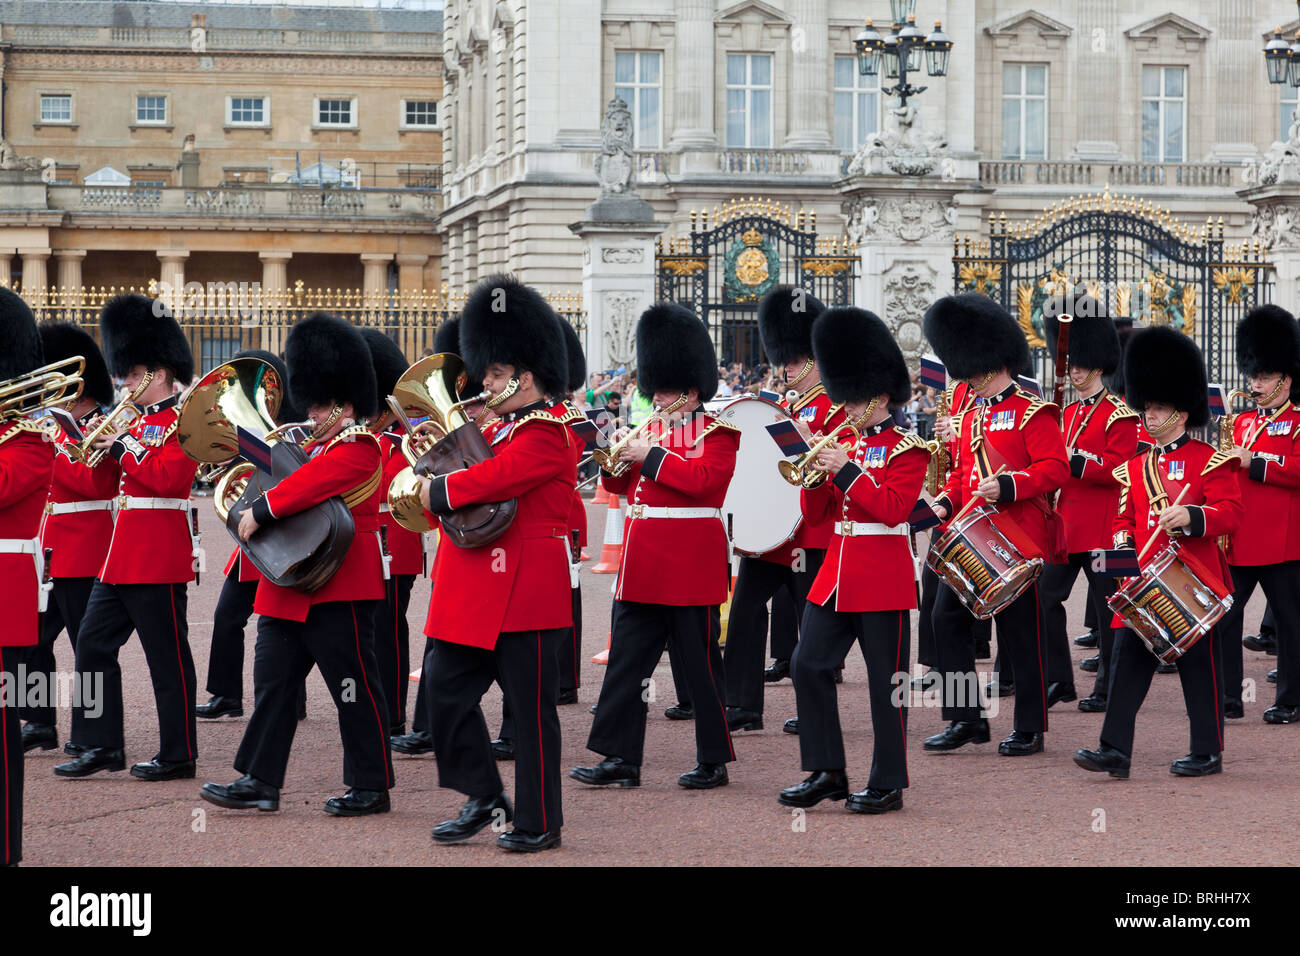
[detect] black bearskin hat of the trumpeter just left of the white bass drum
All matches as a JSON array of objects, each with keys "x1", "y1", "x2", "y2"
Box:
[{"x1": 637, "y1": 302, "x2": 718, "y2": 402}]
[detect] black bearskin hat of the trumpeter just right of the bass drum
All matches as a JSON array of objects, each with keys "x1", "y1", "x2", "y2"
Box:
[{"x1": 811, "y1": 306, "x2": 911, "y2": 406}]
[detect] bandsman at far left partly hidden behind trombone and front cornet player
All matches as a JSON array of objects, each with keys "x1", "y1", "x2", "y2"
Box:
[{"x1": 18, "y1": 323, "x2": 118, "y2": 750}]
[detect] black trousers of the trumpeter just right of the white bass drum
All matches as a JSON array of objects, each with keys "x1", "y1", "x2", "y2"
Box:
[{"x1": 790, "y1": 598, "x2": 911, "y2": 790}]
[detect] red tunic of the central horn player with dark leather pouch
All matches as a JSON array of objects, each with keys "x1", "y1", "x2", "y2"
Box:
[{"x1": 424, "y1": 405, "x2": 573, "y2": 650}]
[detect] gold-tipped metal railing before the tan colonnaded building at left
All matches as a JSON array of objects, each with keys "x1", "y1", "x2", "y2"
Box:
[{"x1": 14, "y1": 280, "x2": 586, "y2": 375}]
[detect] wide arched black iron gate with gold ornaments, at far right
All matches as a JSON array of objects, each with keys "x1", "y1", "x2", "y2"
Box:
[{"x1": 953, "y1": 186, "x2": 1273, "y2": 386}]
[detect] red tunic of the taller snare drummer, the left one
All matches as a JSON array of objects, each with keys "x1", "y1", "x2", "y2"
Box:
[{"x1": 940, "y1": 385, "x2": 1070, "y2": 562}]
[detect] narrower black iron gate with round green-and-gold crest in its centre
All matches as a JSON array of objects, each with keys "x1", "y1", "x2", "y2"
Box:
[{"x1": 655, "y1": 198, "x2": 857, "y2": 367}]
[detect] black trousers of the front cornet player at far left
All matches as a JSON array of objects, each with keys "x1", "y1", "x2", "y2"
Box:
[{"x1": 72, "y1": 581, "x2": 199, "y2": 762}]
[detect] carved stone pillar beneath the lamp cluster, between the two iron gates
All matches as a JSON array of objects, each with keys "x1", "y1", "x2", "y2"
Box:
[{"x1": 840, "y1": 174, "x2": 979, "y2": 368}]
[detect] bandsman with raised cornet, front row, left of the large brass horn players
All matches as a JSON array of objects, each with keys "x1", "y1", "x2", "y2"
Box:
[{"x1": 55, "y1": 294, "x2": 199, "y2": 780}]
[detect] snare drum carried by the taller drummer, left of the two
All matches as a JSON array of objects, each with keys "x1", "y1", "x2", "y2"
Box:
[{"x1": 926, "y1": 505, "x2": 1043, "y2": 620}]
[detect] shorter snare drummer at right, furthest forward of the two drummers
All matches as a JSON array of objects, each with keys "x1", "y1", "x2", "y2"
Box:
[{"x1": 1074, "y1": 326, "x2": 1242, "y2": 778}]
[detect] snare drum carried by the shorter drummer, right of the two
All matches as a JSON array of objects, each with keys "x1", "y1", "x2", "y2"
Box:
[{"x1": 1106, "y1": 544, "x2": 1232, "y2": 663}]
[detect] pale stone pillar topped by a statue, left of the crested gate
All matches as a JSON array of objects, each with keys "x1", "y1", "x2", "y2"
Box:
[{"x1": 569, "y1": 220, "x2": 667, "y2": 369}]
